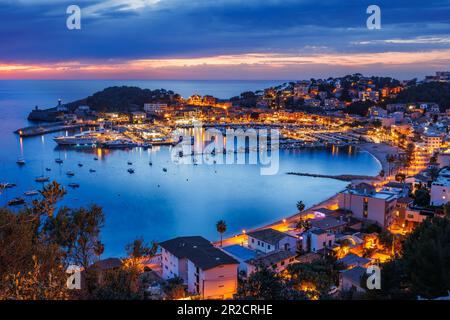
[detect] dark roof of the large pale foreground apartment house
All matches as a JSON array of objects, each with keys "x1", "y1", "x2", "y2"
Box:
[{"x1": 159, "y1": 236, "x2": 239, "y2": 270}]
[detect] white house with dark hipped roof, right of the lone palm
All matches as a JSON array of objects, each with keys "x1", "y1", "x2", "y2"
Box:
[{"x1": 247, "y1": 228, "x2": 297, "y2": 253}]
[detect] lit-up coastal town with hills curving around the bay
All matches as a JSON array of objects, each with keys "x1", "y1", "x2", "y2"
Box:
[{"x1": 2, "y1": 72, "x2": 450, "y2": 300}]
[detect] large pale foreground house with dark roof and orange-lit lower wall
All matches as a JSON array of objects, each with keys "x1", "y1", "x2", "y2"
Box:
[{"x1": 160, "y1": 236, "x2": 239, "y2": 299}]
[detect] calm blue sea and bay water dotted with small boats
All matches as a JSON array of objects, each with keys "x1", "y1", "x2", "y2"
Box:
[{"x1": 0, "y1": 81, "x2": 380, "y2": 256}]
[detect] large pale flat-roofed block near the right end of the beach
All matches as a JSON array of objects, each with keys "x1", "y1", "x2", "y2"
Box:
[{"x1": 338, "y1": 183, "x2": 399, "y2": 228}]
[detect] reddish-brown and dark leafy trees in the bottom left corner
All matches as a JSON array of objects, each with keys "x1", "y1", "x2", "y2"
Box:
[{"x1": 0, "y1": 182, "x2": 103, "y2": 300}]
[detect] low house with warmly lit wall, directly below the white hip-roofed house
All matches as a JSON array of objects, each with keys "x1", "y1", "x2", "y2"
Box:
[{"x1": 247, "y1": 250, "x2": 297, "y2": 276}]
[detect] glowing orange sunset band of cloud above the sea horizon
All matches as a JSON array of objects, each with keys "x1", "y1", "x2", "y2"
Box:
[{"x1": 0, "y1": 49, "x2": 450, "y2": 79}]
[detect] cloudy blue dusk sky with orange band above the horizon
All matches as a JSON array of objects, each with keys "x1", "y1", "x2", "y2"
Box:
[{"x1": 0, "y1": 0, "x2": 450, "y2": 80}]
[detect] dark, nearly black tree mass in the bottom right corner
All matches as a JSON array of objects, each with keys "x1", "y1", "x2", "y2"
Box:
[{"x1": 368, "y1": 217, "x2": 450, "y2": 299}]
